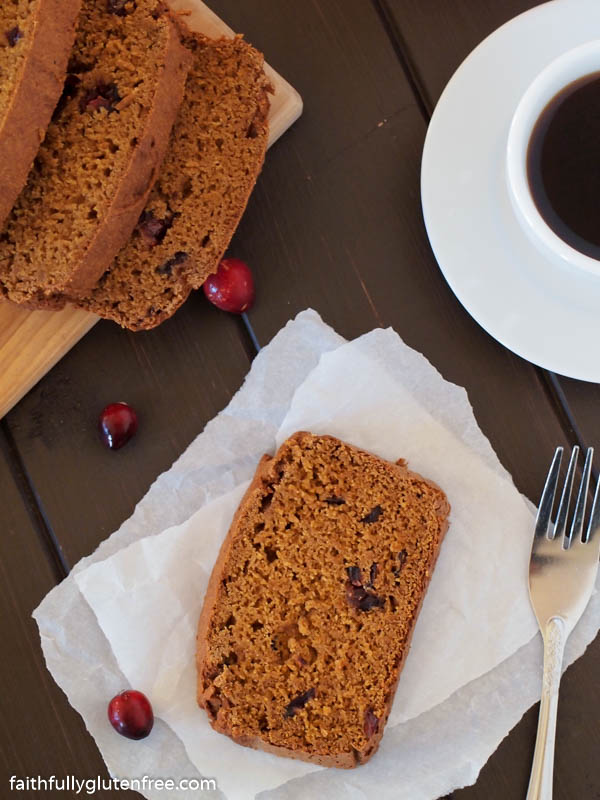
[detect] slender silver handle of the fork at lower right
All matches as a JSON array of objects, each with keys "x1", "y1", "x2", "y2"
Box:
[{"x1": 527, "y1": 617, "x2": 567, "y2": 800}]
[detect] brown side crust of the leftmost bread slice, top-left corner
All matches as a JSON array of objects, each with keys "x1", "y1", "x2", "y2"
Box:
[{"x1": 0, "y1": 0, "x2": 81, "y2": 225}]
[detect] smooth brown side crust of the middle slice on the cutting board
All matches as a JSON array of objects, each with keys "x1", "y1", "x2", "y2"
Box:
[{"x1": 63, "y1": 14, "x2": 191, "y2": 296}]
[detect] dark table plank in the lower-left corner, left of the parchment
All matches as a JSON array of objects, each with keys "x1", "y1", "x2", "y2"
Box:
[{"x1": 0, "y1": 430, "x2": 132, "y2": 798}]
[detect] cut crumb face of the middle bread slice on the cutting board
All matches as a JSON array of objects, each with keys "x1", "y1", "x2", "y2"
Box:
[{"x1": 0, "y1": 0, "x2": 176, "y2": 303}]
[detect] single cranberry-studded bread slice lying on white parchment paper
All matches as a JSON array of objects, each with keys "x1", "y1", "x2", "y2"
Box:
[{"x1": 197, "y1": 432, "x2": 450, "y2": 767}]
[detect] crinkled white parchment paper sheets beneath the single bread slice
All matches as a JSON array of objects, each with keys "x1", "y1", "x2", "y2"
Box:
[{"x1": 35, "y1": 312, "x2": 600, "y2": 800}]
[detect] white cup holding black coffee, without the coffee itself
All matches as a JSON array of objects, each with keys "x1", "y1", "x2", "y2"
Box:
[{"x1": 506, "y1": 39, "x2": 600, "y2": 277}]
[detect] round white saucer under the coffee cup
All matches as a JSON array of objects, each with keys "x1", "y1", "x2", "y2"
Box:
[{"x1": 421, "y1": 0, "x2": 600, "y2": 382}]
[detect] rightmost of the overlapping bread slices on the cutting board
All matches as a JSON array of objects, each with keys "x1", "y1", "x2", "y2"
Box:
[{"x1": 74, "y1": 33, "x2": 271, "y2": 330}]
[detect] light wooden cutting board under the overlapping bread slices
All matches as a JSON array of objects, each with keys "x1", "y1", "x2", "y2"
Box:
[{"x1": 0, "y1": 0, "x2": 302, "y2": 418}]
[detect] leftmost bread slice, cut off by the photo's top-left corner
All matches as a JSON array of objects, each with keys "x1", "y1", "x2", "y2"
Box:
[{"x1": 0, "y1": 0, "x2": 81, "y2": 225}]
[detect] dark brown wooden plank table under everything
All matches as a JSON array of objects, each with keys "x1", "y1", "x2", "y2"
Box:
[{"x1": 0, "y1": 0, "x2": 600, "y2": 800}]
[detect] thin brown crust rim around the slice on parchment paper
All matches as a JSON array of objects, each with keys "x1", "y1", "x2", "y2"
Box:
[{"x1": 196, "y1": 431, "x2": 450, "y2": 769}]
